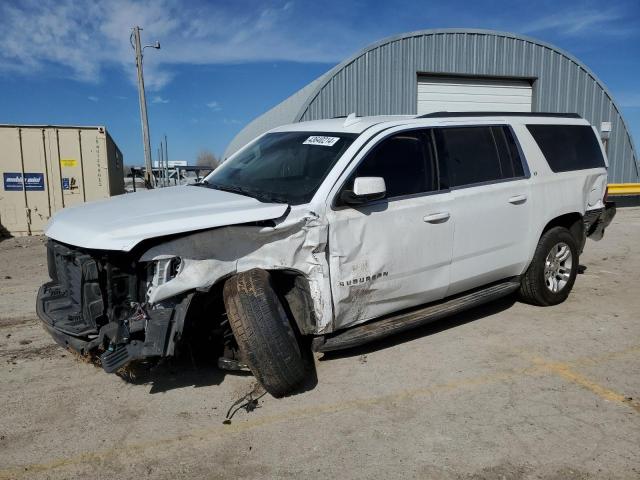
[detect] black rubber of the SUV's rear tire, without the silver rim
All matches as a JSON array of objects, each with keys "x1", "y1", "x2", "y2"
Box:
[{"x1": 519, "y1": 227, "x2": 579, "y2": 307}]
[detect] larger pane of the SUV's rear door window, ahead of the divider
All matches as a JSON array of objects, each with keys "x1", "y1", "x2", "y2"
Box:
[{"x1": 435, "y1": 127, "x2": 504, "y2": 187}]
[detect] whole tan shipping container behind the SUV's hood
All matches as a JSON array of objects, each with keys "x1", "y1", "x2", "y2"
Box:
[{"x1": 0, "y1": 125, "x2": 124, "y2": 236}]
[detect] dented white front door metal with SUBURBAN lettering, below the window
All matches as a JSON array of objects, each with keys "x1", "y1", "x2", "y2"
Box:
[{"x1": 327, "y1": 192, "x2": 455, "y2": 329}]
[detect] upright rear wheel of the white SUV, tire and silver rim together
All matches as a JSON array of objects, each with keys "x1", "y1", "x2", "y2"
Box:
[{"x1": 519, "y1": 227, "x2": 579, "y2": 306}]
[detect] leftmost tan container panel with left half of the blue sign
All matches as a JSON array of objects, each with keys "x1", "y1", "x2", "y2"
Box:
[{"x1": 0, "y1": 127, "x2": 29, "y2": 235}]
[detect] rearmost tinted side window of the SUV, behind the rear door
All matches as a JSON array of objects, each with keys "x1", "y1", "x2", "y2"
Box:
[{"x1": 527, "y1": 125, "x2": 605, "y2": 172}]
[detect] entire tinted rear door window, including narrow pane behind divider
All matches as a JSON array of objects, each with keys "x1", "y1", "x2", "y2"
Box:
[{"x1": 435, "y1": 126, "x2": 524, "y2": 188}]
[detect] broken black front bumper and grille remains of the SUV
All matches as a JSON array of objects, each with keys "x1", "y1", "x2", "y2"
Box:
[{"x1": 36, "y1": 242, "x2": 192, "y2": 373}]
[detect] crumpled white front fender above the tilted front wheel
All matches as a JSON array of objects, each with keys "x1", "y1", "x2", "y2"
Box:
[{"x1": 140, "y1": 209, "x2": 333, "y2": 334}]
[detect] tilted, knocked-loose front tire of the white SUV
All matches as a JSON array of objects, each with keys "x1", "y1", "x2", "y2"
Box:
[{"x1": 224, "y1": 268, "x2": 307, "y2": 398}]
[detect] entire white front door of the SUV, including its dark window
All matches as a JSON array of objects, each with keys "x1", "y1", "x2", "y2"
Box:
[{"x1": 327, "y1": 130, "x2": 454, "y2": 329}]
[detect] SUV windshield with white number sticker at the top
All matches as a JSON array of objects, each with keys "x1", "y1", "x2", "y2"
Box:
[{"x1": 203, "y1": 132, "x2": 357, "y2": 205}]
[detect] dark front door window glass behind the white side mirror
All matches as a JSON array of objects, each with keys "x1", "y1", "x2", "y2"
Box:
[{"x1": 345, "y1": 130, "x2": 437, "y2": 198}]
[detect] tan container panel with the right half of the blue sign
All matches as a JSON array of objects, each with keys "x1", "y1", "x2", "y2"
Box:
[{"x1": 21, "y1": 128, "x2": 51, "y2": 233}]
